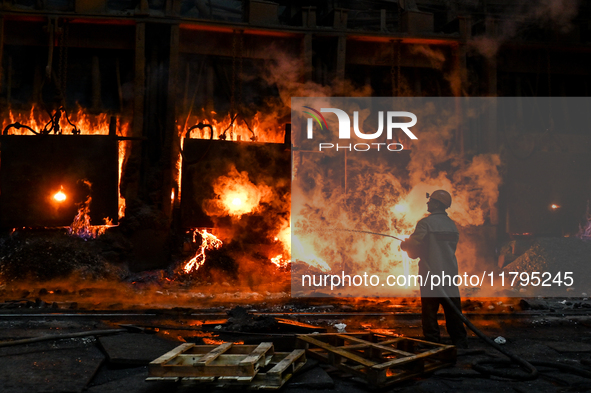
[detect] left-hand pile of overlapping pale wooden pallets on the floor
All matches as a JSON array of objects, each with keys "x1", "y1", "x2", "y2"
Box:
[{"x1": 146, "y1": 342, "x2": 306, "y2": 389}]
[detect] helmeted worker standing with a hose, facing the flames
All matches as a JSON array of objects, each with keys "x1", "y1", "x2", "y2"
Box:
[{"x1": 400, "y1": 190, "x2": 468, "y2": 348}]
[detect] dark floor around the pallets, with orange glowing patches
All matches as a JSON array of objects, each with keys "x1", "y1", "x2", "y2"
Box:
[{"x1": 0, "y1": 301, "x2": 591, "y2": 393}]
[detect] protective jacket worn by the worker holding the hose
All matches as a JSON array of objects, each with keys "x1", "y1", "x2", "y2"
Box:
[{"x1": 408, "y1": 212, "x2": 460, "y2": 297}]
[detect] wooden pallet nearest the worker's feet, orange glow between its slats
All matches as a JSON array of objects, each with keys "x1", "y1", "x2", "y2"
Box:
[{"x1": 298, "y1": 333, "x2": 456, "y2": 387}]
